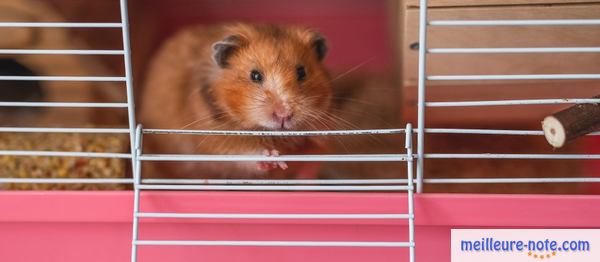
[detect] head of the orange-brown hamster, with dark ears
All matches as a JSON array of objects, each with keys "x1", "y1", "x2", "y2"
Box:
[{"x1": 211, "y1": 24, "x2": 332, "y2": 130}]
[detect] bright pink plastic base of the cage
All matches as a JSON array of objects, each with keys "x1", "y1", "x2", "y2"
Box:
[{"x1": 0, "y1": 191, "x2": 600, "y2": 262}]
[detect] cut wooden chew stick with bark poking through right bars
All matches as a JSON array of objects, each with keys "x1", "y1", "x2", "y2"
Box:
[{"x1": 542, "y1": 96, "x2": 600, "y2": 148}]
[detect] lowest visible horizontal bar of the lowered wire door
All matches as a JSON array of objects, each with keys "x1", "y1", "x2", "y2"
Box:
[{"x1": 133, "y1": 240, "x2": 414, "y2": 247}]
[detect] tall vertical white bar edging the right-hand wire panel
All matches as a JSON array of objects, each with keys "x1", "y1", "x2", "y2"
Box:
[{"x1": 417, "y1": 0, "x2": 427, "y2": 193}]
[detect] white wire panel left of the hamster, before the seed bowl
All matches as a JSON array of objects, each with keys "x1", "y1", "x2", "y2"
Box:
[{"x1": 0, "y1": 0, "x2": 136, "y2": 184}]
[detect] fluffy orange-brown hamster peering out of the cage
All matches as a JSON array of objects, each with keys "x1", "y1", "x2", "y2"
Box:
[{"x1": 140, "y1": 24, "x2": 332, "y2": 178}]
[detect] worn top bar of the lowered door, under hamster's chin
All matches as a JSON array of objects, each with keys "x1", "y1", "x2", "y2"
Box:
[{"x1": 143, "y1": 129, "x2": 406, "y2": 136}]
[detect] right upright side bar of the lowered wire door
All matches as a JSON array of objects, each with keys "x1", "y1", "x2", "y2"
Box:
[{"x1": 404, "y1": 123, "x2": 416, "y2": 262}]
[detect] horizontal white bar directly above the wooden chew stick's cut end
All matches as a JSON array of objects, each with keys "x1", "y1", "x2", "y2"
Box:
[{"x1": 425, "y1": 98, "x2": 600, "y2": 107}]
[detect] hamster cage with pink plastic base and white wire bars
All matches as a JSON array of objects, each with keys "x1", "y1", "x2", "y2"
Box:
[{"x1": 0, "y1": 0, "x2": 600, "y2": 261}]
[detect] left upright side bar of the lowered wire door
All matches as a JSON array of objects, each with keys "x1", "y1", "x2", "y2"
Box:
[{"x1": 131, "y1": 125, "x2": 142, "y2": 262}]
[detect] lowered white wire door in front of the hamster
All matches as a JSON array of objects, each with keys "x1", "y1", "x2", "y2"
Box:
[{"x1": 131, "y1": 124, "x2": 415, "y2": 261}]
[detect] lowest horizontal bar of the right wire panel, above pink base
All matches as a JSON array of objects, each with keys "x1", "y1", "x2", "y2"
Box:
[{"x1": 423, "y1": 177, "x2": 600, "y2": 184}]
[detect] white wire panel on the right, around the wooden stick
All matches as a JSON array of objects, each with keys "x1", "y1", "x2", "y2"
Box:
[{"x1": 417, "y1": 0, "x2": 600, "y2": 192}]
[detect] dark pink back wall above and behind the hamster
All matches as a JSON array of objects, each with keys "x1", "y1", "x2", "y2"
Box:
[{"x1": 131, "y1": 0, "x2": 394, "y2": 72}]
